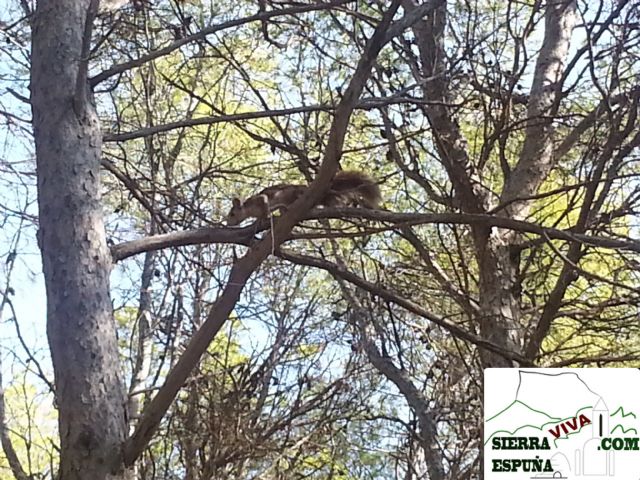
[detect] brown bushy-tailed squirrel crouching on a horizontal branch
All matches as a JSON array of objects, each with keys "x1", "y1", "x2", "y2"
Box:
[{"x1": 227, "y1": 170, "x2": 382, "y2": 226}]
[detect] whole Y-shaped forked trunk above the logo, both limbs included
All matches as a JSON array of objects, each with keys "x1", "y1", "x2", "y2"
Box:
[{"x1": 410, "y1": 0, "x2": 576, "y2": 367}]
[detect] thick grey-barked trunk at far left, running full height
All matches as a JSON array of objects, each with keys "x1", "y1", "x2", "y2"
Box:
[{"x1": 31, "y1": 0, "x2": 126, "y2": 480}]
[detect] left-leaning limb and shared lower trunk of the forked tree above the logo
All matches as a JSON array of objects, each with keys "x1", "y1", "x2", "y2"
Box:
[{"x1": 404, "y1": 0, "x2": 519, "y2": 367}]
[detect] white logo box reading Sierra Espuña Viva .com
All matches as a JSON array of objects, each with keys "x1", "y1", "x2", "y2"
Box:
[{"x1": 484, "y1": 368, "x2": 640, "y2": 480}]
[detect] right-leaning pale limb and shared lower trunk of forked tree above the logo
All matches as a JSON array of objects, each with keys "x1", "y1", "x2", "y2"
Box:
[{"x1": 476, "y1": 0, "x2": 576, "y2": 367}]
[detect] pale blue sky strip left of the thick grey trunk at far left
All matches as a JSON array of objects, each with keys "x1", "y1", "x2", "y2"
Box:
[{"x1": 0, "y1": 0, "x2": 49, "y2": 383}]
